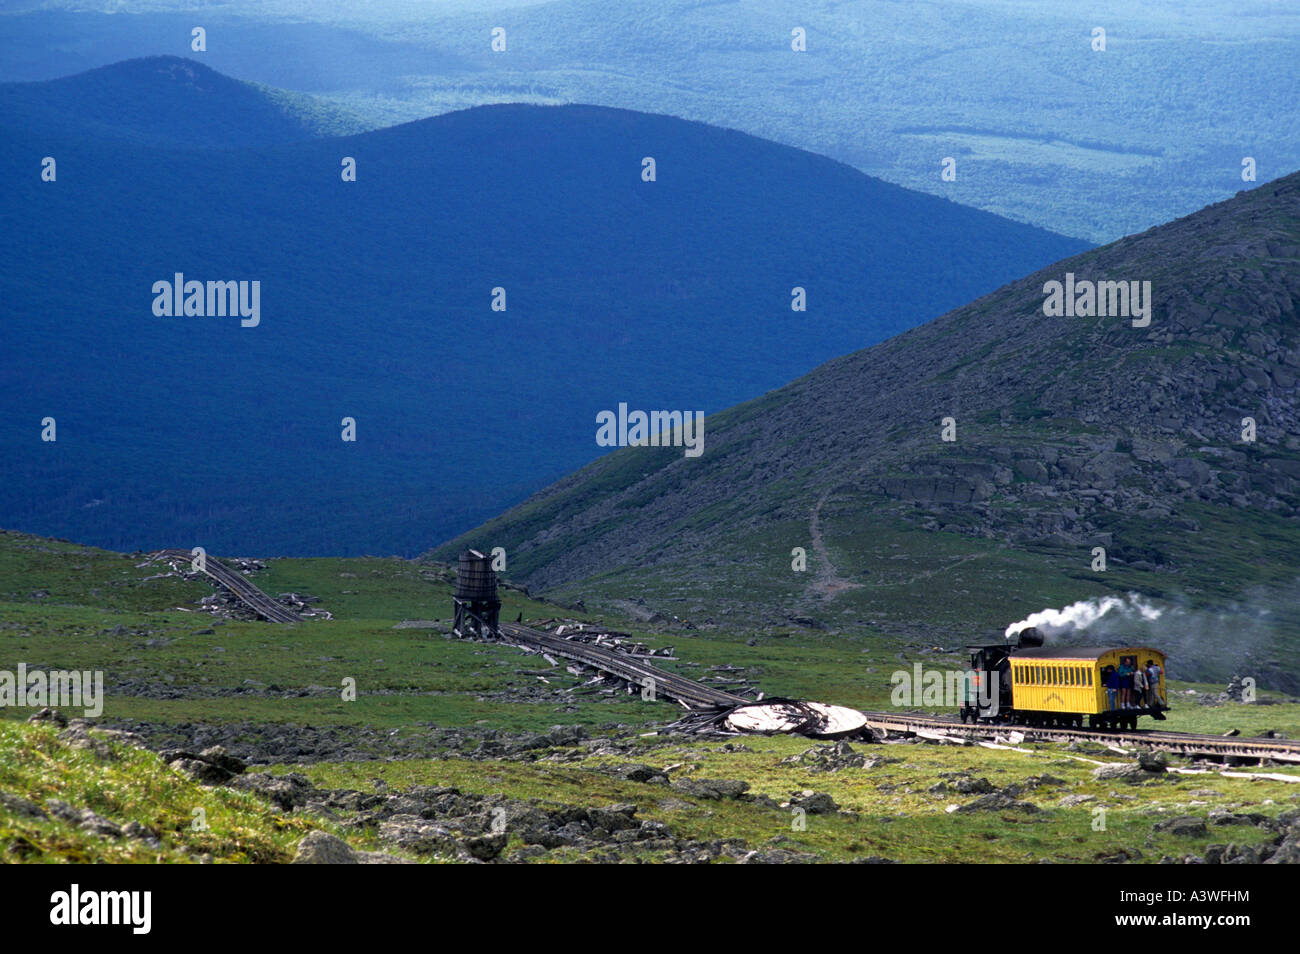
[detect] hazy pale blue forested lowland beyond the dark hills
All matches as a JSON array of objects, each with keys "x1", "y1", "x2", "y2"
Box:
[{"x1": 0, "y1": 0, "x2": 1300, "y2": 242}]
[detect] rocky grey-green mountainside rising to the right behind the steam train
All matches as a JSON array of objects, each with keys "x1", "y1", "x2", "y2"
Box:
[{"x1": 436, "y1": 174, "x2": 1300, "y2": 689}]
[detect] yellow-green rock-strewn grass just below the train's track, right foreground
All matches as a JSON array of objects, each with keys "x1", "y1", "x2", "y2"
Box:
[{"x1": 292, "y1": 737, "x2": 1300, "y2": 863}]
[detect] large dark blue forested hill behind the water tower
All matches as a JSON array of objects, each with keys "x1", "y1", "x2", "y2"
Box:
[{"x1": 0, "y1": 59, "x2": 1084, "y2": 555}]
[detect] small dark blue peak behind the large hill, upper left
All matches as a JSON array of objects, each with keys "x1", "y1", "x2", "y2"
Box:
[{"x1": 0, "y1": 56, "x2": 365, "y2": 148}]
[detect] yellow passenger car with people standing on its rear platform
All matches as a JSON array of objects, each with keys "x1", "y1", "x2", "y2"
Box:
[{"x1": 1008, "y1": 646, "x2": 1169, "y2": 729}]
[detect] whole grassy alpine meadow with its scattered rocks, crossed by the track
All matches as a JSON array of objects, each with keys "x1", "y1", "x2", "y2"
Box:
[{"x1": 0, "y1": 530, "x2": 1300, "y2": 863}]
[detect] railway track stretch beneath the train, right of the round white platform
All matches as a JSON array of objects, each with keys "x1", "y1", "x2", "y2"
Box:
[{"x1": 863, "y1": 712, "x2": 1300, "y2": 764}]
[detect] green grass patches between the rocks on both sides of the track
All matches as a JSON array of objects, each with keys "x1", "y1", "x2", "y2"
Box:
[{"x1": 0, "y1": 522, "x2": 1300, "y2": 863}]
